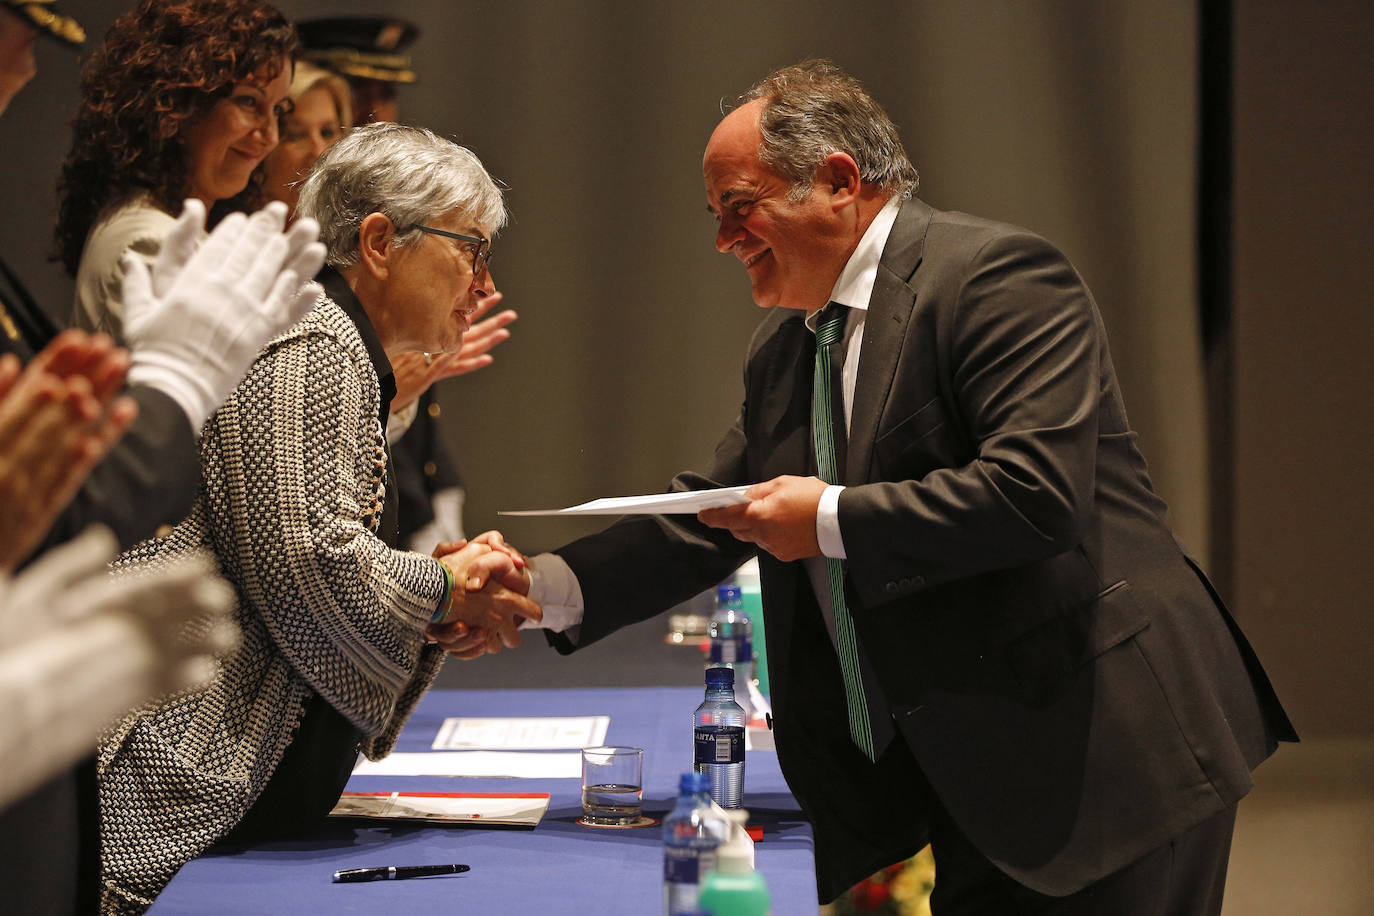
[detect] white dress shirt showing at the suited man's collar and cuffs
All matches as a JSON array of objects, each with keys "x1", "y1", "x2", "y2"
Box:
[{"x1": 521, "y1": 195, "x2": 901, "y2": 641}]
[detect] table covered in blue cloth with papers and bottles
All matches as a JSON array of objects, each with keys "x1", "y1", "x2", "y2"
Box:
[{"x1": 151, "y1": 687, "x2": 819, "y2": 916}]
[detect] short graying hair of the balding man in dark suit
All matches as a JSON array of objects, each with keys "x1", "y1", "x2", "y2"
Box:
[{"x1": 739, "y1": 60, "x2": 919, "y2": 201}]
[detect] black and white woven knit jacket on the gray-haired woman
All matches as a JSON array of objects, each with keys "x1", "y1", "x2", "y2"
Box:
[{"x1": 99, "y1": 297, "x2": 445, "y2": 913}]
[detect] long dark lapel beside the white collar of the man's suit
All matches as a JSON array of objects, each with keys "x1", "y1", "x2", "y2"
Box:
[{"x1": 844, "y1": 198, "x2": 934, "y2": 486}]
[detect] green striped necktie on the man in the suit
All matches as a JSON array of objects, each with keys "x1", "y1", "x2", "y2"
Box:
[{"x1": 811, "y1": 302, "x2": 877, "y2": 761}]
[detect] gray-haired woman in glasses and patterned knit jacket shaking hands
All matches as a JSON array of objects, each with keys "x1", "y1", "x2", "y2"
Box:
[{"x1": 99, "y1": 124, "x2": 540, "y2": 912}]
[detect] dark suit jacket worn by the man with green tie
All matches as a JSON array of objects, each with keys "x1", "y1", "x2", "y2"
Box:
[{"x1": 559, "y1": 201, "x2": 1296, "y2": 898}]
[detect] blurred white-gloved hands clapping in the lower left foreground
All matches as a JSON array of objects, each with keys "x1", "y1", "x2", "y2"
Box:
[{"x1": 0, "y1": 529, "x2": 238, "y2": 809}]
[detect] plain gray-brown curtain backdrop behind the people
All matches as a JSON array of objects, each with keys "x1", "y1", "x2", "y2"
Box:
[{"x1": 0, "y1": 0, "x2": 1374, "y2": 737}]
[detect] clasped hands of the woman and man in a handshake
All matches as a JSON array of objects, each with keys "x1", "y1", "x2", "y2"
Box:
[{"x1": 425, "y1": 531, "x2": 544, "y2": 661}]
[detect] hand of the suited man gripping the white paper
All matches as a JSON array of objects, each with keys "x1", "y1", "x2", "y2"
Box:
[{"x1": 697, "y1": 475, "x2": 826, "y2": 563}]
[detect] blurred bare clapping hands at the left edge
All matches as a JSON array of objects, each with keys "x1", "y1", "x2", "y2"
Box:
[{"x1": 0, "y1": 331, "x2": 139, "y2": 571}]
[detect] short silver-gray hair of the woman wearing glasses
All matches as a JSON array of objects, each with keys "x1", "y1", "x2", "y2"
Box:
[{"x1": 295, "y1": 122, "x2": 506, "y2": 268}]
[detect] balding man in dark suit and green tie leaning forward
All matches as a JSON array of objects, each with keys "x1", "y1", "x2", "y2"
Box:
[{"x1": 431, "y1": 62, "x2": 1296, "y2": 913}]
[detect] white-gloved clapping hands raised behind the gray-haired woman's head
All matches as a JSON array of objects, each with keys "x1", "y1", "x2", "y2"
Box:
[{"x1": 124, "y1": 201, "x2": 324, "y2": 431}]
